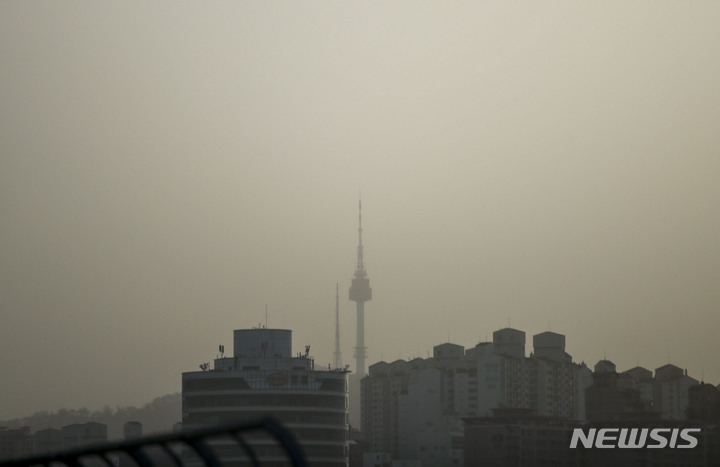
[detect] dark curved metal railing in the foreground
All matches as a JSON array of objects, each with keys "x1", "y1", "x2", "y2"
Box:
[{"x1": 0, "y1": 418, "x2": 307, "y2": 467}]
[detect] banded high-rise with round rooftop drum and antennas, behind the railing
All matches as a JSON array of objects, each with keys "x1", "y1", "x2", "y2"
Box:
[{"x1": 182, "y1": 328, "x2": 348, "y2": 467}]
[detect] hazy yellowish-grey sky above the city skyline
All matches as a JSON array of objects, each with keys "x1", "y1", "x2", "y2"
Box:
[{"x1": 0, "y1": 1, "x2": 720, "y2": 419}]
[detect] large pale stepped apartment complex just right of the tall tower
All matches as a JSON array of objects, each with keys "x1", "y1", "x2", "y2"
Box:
[{"x1": 362, "y1": 328, "x2": 592, "y2": 467}]
